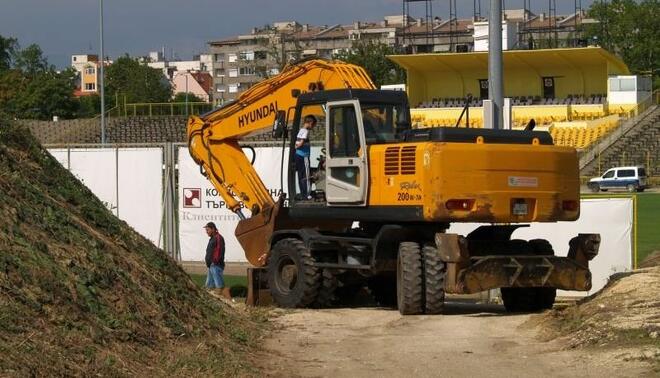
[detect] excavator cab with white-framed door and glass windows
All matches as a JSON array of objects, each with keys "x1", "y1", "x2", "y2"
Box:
[{"x1": 288, "y1": 89, "x2": 410, "y2": 208}]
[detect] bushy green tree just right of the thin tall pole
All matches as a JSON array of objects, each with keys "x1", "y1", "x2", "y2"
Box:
[{"x1": 106, "y1": 55, "x2": 172, "y2": 103}]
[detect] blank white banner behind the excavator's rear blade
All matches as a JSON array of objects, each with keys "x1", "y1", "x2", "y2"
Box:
[{"x1": 447, "y1": 198, "x2": 633, "y2": 296}]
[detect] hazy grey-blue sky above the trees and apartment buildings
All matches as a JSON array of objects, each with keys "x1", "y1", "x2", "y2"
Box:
[{"x1": 0, "y1": 0, "x2": 593, "y2": 68}]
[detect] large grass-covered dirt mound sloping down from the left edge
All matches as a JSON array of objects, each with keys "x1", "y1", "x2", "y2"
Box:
[{"x1": 0, "y1": 120, "x2": 259, "y2": 376}]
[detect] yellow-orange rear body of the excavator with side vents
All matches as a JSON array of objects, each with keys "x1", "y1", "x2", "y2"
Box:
[{"x1": 368, "y1": 140, "x2": 579, "y2": 223}]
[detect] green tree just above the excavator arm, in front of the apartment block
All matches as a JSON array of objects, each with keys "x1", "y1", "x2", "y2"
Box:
[{"x1": 334, "y1": 41, "x2": 406, "y2": 87}]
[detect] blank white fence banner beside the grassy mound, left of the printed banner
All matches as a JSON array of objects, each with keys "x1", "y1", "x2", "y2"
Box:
[{"x1": 48, "y1": 148, "x2": 163, "y2": 246}]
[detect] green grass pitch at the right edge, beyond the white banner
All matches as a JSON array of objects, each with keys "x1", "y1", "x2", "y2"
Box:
[{"x1": 588, "y1": 192, "x2": 660, "y2": 264}]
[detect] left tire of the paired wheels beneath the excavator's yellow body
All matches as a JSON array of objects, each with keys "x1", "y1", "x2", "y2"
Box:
[{"x1": 396, "y1": 242, "x2": 424, "y2": 315}]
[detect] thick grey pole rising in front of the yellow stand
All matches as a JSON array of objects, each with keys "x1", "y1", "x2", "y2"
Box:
[{"x1": 488, "y1": 0, "x2": 504, "y2": 130}]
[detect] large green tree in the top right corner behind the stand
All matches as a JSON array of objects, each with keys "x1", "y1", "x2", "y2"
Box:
[{"x1": 585, "y1": 0, "x2": 660, "y2": 86}]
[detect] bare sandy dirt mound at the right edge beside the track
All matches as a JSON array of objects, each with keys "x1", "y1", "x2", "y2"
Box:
[{"x1": 536, "y1": 267, "x2": 660, "y2": 363}]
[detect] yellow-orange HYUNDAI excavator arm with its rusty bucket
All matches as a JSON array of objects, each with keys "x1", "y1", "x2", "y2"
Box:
[{"x1": 187, "y1": 59, "x2": 375, "y2": 266}]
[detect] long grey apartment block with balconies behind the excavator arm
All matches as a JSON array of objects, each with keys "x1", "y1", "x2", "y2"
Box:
[{"x1": 208, "y1": 9, "x2": 588, "y2": 104}]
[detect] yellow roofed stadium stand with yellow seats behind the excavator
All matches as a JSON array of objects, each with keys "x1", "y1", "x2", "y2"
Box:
[{"x1": 390, "y1": 47, "x2": 648, "y2": 149}]
